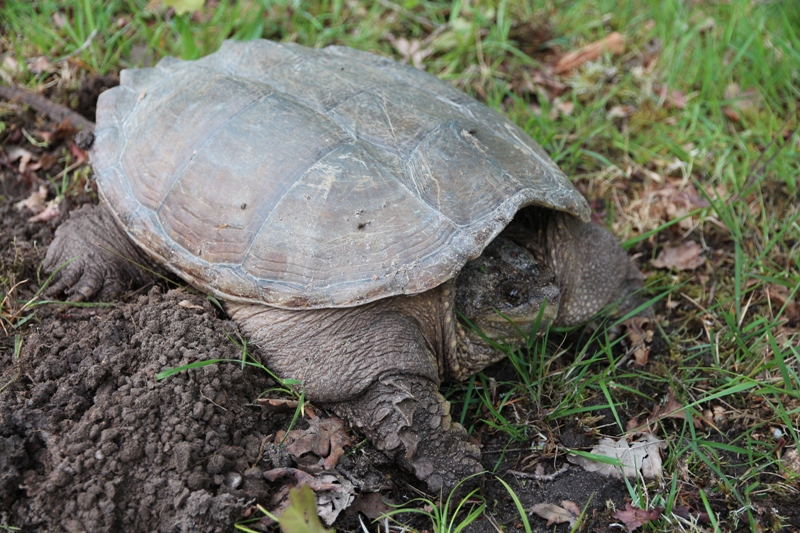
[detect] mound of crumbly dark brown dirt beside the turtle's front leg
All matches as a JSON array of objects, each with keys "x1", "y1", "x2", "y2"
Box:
[{"x1": 0, "y1": 288, "x2": 283, "y2": 531}]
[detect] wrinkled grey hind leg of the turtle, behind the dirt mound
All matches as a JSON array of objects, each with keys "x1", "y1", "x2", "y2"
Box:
[{"x1": 43, "y1": 206, "x2": 152, "y2": 301}]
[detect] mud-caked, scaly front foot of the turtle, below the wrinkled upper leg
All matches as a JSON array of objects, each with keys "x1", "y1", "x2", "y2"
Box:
[{"x1": 329, "y1": 375, "x2": 483, "y2": 494}]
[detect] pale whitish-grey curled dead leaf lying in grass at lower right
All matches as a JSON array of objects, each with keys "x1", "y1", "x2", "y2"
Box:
[{"x1": 569, "y1": 433, "x2": 667, "y2": 479}]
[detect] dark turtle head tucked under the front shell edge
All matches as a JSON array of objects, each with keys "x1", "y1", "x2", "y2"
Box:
[{"x1": 455, "y1": 237, "x2": 560, "y2": 342}]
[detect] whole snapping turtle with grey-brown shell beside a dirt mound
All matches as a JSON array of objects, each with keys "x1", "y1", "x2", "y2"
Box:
[{"x1": 45, "y1": 41, "x2": 642, "y2": 490}]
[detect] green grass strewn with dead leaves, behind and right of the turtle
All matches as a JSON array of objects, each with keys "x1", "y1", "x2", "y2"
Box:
[{"x1": 0, "y1": 0, "x2": 800, "y2": 531}]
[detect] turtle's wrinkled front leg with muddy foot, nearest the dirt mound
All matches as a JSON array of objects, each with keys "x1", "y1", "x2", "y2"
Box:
[{"x1": 226, "y1": 295, "x2": 482, "y2": 493}]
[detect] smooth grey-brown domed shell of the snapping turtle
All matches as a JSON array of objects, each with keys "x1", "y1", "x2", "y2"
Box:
[{"x1": 91, "y1": 40, "x2": 589, "y2": 309}]
